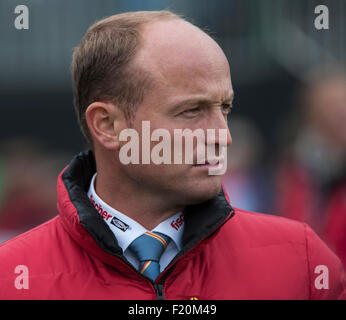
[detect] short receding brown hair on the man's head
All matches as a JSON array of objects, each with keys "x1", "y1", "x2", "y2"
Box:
[{"x1": 71, "y1": 10, "x2": 182, "y2": 145}]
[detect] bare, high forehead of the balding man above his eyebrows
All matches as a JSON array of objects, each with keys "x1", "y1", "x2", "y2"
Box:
[{"x1": 135, "y1": 19, "x2": 231, "y2": 94}]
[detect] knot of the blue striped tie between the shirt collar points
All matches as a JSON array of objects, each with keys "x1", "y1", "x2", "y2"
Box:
[{"x1": 129, "y1": 231, "x2": 171, "y2": 262}]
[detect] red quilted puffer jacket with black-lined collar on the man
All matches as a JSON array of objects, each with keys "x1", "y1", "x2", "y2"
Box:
[{"x1": 0, "y1": 151, "x2": 345, "y2": 299}]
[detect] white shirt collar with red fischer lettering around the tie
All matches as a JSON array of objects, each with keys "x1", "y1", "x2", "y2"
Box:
[{"x1": 88, "y1": 173, "x2": 184, "y2": 272}]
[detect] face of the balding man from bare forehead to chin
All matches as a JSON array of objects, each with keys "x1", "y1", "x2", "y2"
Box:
[{"x1": 117, "y1": 20, "x2": 233, "y2": 205}]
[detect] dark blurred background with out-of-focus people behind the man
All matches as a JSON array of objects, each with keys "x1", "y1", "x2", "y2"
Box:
[{"x1": 0, "y1": 0, "x2": 346, "y2": 265}]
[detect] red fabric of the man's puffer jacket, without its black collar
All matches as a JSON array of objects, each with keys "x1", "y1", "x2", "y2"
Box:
[{"x1": 0, "y1": 168, "x2": 345, "y2": 300}]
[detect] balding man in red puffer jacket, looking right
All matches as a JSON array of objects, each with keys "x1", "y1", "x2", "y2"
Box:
[{"x1": 0, "y1": 11, "x2": 345, "y2": 299}]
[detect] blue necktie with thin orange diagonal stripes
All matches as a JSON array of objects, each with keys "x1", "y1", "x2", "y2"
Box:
[{"x1": 129, "y1": 231, "x2": 171, "y2": 281}]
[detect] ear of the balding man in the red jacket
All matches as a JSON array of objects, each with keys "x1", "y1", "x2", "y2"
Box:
[{"x1": 85, "y1": 102, "x2": 127, "y2": 150}]
